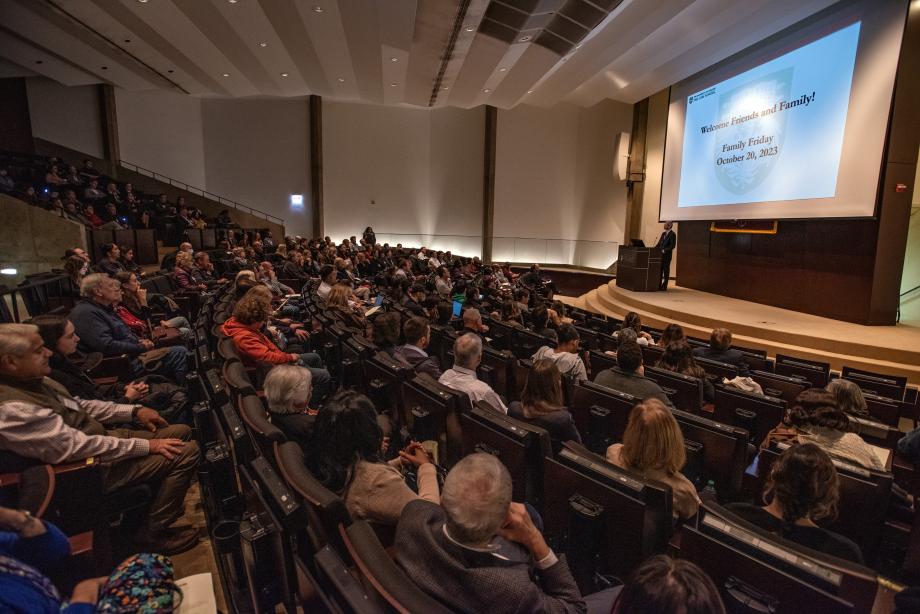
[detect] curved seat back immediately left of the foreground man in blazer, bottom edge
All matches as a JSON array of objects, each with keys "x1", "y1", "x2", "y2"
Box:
[{"x1": 342, "y1": 520, "x2": 449, "y2": 614}]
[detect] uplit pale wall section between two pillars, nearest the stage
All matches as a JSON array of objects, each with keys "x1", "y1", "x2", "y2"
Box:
[{"x1": 492, "y1": 101, "x2": 632, "y2": 268}]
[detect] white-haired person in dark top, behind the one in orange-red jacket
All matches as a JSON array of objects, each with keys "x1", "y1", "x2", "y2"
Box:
[{"x1": 263, "y1": 365, "x2": 316, "y2": 447}]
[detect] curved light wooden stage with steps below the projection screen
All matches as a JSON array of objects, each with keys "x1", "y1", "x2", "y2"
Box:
[{"x1": 557, "y1": 280, "x2": 920, "y2": 384}]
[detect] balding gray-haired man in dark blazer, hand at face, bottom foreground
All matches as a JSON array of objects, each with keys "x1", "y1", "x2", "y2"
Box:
[{"x1": 395, "y1": 452, "x2": 619, "y2": 613}]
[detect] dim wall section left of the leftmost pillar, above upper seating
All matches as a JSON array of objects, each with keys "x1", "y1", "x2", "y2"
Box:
[{"x1": 26, "y1": 77, "x2": 103, "y2": 158}]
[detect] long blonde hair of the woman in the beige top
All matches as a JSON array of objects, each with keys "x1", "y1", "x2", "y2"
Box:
[{"x1": 620, "y1": 399, "x2": 687, "y2": 475}]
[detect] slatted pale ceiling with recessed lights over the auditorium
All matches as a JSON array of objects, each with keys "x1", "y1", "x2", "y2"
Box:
[{"x1": 0, "y1": 0, "x2": 836, "y2": 108}]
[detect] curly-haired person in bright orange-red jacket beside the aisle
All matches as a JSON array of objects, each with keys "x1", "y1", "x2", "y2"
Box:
[{"x1": 221, "y1": 291, "x2": 330, "y2": 392}]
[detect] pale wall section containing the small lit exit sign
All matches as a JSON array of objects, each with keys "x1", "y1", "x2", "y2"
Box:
[{"x1": 201, "y1": 100, "x2": 312, "y2": 236}]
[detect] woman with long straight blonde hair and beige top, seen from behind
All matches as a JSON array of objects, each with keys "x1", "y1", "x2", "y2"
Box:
[{"x1": 607, "y1": 398, "x2": 700, "y2": 520}]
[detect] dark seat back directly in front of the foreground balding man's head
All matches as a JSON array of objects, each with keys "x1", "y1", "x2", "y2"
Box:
[{"x1": 460, "y1": 401, "x2": 552, "y2": 511}]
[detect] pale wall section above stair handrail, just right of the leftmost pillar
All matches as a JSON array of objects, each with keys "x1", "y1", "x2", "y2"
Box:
[{"x1": 113, "y1": 89, "x2": 206, "y2": 188}]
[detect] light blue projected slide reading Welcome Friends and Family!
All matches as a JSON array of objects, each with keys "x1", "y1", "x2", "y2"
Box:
[{"x1": 677, "y1": 23, "x2": 860, "y2": 207}]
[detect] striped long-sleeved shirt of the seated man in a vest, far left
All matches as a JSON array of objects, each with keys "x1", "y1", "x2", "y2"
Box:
[{"x1": 0, "y1": 398, "x2": 150, "y2": 465}]
